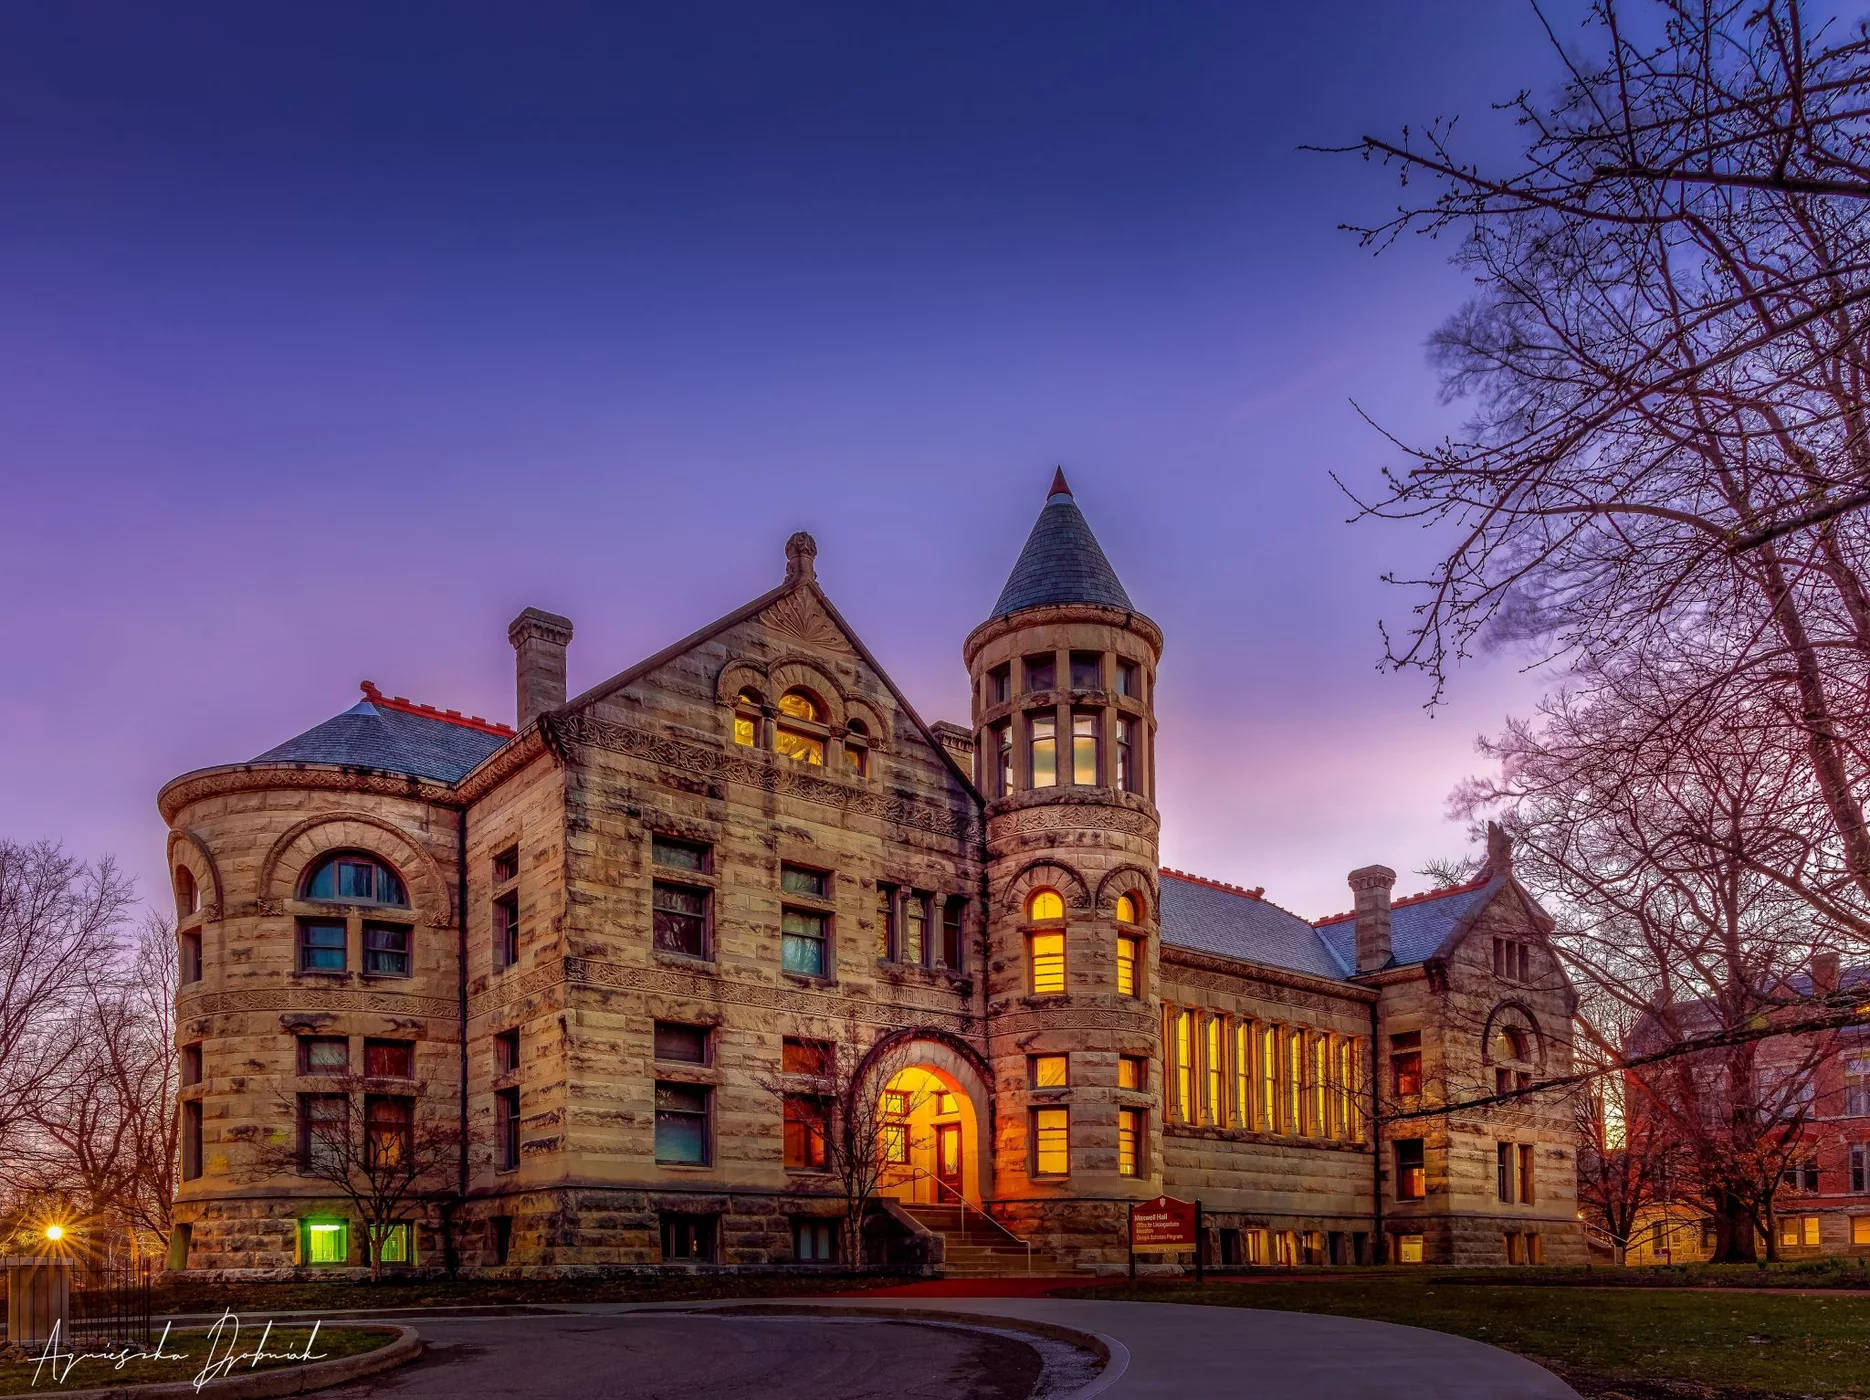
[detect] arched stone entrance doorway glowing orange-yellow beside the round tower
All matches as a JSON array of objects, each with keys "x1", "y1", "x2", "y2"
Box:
[{"x1": 870, "y1": 1036, "x2": 993, "y2": 1207}]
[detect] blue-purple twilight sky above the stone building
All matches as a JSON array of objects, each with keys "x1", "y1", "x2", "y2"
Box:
[{"x1": 0, "y1": 0, "x2": 1578, "y2": 918}]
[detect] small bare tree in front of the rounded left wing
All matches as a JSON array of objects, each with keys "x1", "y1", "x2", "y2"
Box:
[{"x1": 245, "y1": 1075, "x2": 462, "y2": 1282}]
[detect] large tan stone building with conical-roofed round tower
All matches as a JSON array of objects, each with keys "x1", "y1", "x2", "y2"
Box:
[{"x1": 159, "y1": 473, "x2": 1582, "y2": 1271}]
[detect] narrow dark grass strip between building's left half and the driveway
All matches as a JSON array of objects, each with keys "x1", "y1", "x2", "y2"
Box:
[{"x1": 151, "y1": 1273, "x2": 909, "y2": 1314}]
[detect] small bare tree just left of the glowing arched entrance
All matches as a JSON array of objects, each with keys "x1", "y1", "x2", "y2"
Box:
[{"x1": 759, "y1": 1015, "x2": 931, "y2": 1267}]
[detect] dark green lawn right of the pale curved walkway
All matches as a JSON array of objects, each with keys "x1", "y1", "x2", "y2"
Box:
[{"x1": 1070, "y1": 1275, "x2": 1870, "y2": 1400}]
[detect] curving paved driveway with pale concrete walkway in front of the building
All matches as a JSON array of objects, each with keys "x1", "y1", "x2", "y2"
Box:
[{"x1": 327, "y1": 1297, "x2": 1576, "y2": 1400}]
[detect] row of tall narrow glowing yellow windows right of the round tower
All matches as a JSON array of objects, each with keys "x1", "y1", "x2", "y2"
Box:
[{"x1": 1163, "y1": 1006, "x2": 1367, "y2": 1142}]
